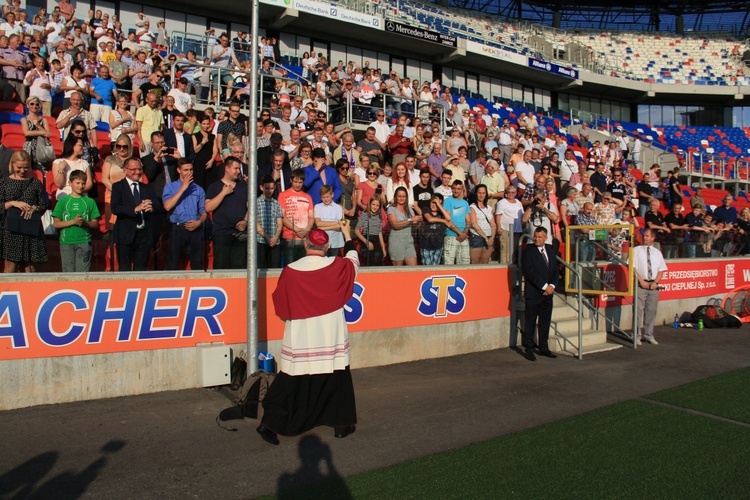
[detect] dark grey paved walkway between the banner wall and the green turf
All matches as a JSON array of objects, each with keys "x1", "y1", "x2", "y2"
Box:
[{"x1": 0, "y1": 327, "x2": 750, "y2": 499}]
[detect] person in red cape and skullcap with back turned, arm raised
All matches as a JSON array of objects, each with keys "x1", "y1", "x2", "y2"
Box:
[{"x1": 256, "y1": 220, "x2": 359, "y2": 444}]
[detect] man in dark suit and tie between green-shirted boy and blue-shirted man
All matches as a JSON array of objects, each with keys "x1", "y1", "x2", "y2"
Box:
[{"x1": 111, "y1": 158, "x2": 162, "y2": 271}]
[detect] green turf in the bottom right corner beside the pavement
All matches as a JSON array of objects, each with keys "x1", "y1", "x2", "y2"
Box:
[{"x1": 270, "y1": 370, "x2": 750, "y2": 499}]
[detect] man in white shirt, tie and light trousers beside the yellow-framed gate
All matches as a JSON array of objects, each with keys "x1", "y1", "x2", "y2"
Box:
[{"x1": 634, "y1": 228, "x2": 667, "y2": 345}]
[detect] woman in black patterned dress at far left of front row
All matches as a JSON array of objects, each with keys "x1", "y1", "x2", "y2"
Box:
[{"x1": 0, "y1": 151, "x2": 47, "y2": 273}]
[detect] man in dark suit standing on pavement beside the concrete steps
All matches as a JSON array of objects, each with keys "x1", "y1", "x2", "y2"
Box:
[{"x1": 521, "y1": 227, "x2": 559, "y2": 361}]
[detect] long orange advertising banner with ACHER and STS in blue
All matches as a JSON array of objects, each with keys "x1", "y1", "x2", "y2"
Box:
[{"x1": 0, "y1": 267, "x2": 510, "y2": 360}]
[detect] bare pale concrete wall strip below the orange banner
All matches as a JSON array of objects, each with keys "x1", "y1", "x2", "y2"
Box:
[{"x1": 0, "y1": 317, "x2": 510, "y2": 410}]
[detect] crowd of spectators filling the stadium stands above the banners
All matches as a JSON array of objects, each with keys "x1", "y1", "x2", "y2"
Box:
[{"x1": 0, "y1": 2, "x2": 750, "y2": 272}]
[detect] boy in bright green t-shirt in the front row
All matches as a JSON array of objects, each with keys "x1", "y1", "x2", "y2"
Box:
[{"x1": 52, "y1": 170, "x2": 101, "y2": 273}]
